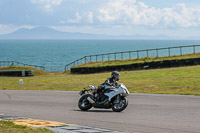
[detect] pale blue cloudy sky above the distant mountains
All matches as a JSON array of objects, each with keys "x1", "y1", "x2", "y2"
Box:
[{"x1": 0, "y1": 0, "x2": 200, "y2": 37}]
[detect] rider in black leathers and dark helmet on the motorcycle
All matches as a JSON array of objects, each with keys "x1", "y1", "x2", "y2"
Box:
[{"x1": 97, "y1": 71, "x2": 120, "y2": 102}]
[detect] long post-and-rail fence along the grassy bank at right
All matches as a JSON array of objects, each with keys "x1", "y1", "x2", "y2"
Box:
[{"x1": 65, "y1": 45, "x2": 200, "y2": 71}]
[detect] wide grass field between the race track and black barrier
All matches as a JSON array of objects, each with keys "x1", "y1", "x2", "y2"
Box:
[{"x1": 0, "y1": 65, "x2": 200, "y2": 95}]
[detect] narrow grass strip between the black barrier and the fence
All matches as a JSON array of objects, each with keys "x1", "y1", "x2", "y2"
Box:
[{"x1": 73, "y1": 53, "x2": 200, "y2": 68}]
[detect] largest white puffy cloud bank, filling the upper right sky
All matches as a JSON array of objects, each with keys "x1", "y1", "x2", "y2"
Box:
[{"x1": 97, "y1": 0, "x2": 200, "y2": 28}]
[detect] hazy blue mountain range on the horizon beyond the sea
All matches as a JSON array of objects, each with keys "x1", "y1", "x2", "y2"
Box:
[{"x1": 0, "y1": 27, "x2": 197, "y2": 40}]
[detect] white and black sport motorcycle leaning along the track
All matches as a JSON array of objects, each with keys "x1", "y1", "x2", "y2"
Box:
[{"x1": 78, "y1": 83, "x2": 129, "y2": 112}]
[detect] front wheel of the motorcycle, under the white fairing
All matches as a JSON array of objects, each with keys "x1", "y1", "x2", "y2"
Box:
[{"x1": 112, "y1": 97, "x2": 128, "y2": 112}]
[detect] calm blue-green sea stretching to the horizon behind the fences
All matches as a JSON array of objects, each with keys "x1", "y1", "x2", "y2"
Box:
[{"x1": 0, "y1": 40, "x2": 200, "y2": 66}]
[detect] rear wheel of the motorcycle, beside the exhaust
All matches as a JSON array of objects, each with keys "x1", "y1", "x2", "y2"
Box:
[{"x1": 78, "y1": 94, "x2": 92, "y2": 111}]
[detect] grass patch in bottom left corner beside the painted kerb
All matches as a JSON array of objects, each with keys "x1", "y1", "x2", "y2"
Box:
[{"x1": 0, "y1": 120, "x2": 53, "y2": 133}]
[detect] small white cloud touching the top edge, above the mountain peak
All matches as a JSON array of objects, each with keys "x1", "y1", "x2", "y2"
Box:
[{"x1": 31, "y1": 0, "x2": 63, "y2": 11}]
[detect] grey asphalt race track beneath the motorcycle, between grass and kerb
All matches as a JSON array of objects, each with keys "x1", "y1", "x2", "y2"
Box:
[{"x1": 0, "y1": 90, "x2": 200, "y2": 133}]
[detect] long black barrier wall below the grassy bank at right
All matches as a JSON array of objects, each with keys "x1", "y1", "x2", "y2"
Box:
[{"x1": 71, "y1": 58, "x2": 200, "y2": 74}]
